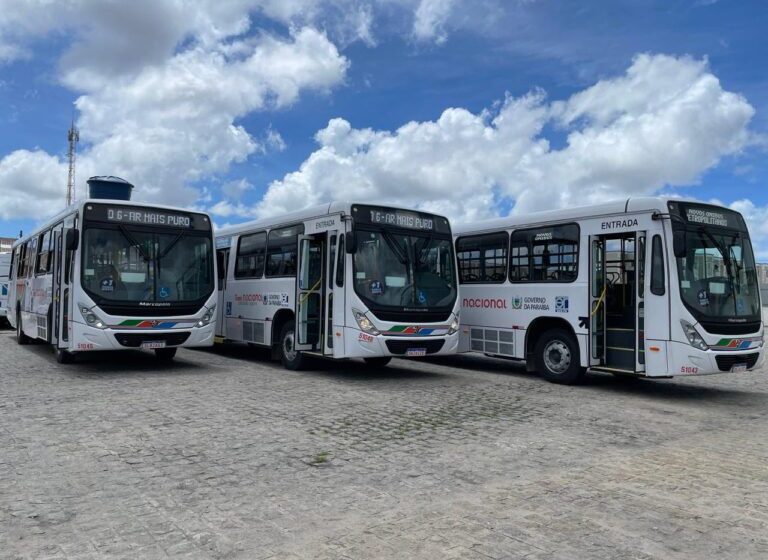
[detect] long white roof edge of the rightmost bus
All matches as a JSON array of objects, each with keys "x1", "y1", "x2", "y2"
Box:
[{"x1": 453, "y1": 196, "x2": 732, "y2": 235}]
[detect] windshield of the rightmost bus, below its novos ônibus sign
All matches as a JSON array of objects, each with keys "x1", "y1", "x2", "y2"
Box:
[{"x1": 677, "y1": 226, "x2": 760, "y2": 319}]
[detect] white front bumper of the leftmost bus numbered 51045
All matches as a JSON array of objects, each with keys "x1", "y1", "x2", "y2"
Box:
[{"x1": 69, "y1": 321, "x2": 216, "y2": 352}]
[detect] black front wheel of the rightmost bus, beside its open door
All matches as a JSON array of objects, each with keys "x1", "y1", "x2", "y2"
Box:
[{"x1": 533, "y1": 329, "x2": 584, "y2": 385}]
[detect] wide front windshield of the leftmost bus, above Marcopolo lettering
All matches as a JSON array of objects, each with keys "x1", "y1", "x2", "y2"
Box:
[{"x1": 82, "y1": 225, "x2": 214, "y2": 305}]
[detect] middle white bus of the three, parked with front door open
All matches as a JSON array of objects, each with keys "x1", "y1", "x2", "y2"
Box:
[{"x1": 216, "y1": 202, "x2": 459, "y2": 369}]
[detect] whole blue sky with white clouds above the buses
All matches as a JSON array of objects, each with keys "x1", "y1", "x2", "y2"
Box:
[{"x1": 0, "y1": 0, "x2": 768, "y2": 260}]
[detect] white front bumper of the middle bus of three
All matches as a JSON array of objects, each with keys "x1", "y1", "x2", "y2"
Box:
[{"x1": 344, "y1": 328, "x2": 459, "y2": 358}]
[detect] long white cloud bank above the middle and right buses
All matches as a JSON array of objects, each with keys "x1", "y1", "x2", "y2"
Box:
[{"x1": 253, "y1": 55, "x2": 754, "y2": 224}]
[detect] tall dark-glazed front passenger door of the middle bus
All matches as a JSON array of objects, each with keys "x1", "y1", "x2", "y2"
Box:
[{"x1": 295, "y1": 233, "x2": 325, "y2": 351}]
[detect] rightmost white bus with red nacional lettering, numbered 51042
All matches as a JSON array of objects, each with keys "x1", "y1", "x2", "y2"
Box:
[{"x1": 456, "y1": 198, "x2": 763, "y2": 383}]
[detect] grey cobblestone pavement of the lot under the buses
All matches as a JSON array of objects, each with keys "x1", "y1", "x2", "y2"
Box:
[{"x1": 0, "y1": 331, "x2": 768, "y2": 560}]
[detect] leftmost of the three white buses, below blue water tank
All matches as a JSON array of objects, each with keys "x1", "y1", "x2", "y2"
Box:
[{"x1": 8, "y1": 199, "x2": 216, "y2": 362}]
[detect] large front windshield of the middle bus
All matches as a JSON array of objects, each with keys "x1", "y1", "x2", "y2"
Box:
[{"x1": 353, "y1": 229, "x2": 456, "y2": 310}]
